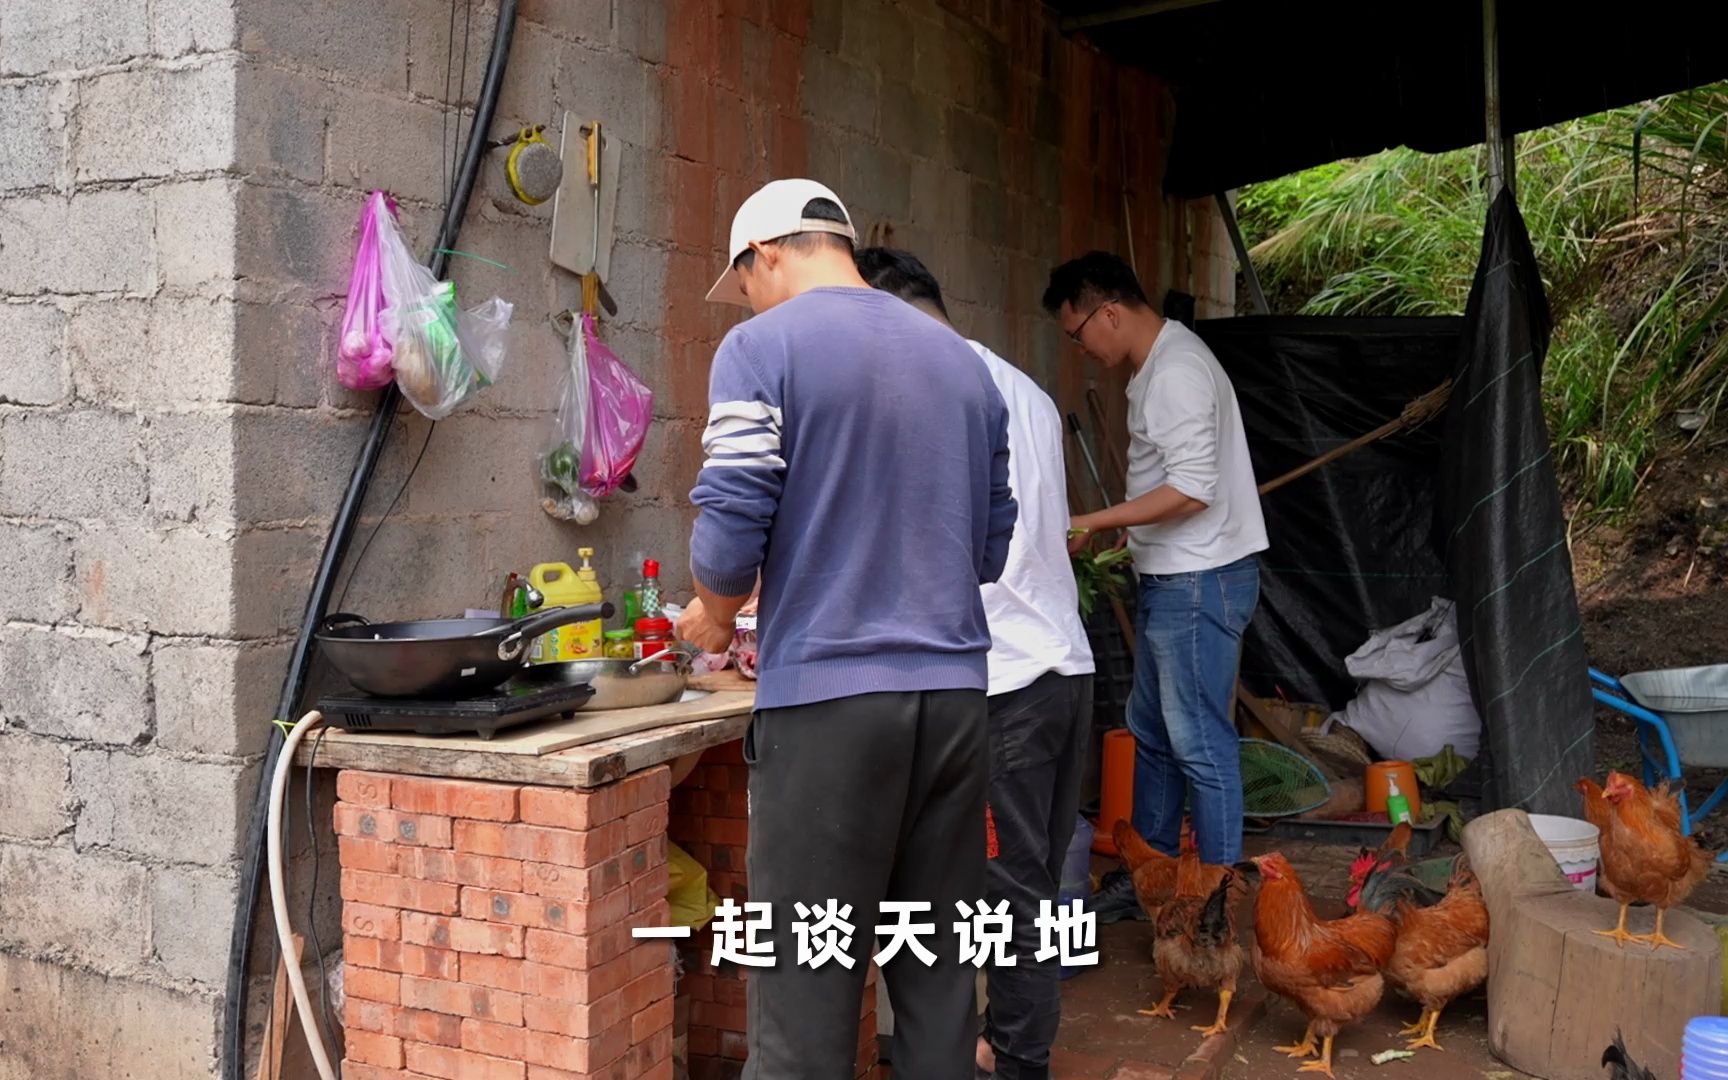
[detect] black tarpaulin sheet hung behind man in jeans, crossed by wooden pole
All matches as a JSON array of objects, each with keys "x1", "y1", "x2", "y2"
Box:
[{"x1": 1196, "y1": 316, "x2": 1464, "y2": 708}]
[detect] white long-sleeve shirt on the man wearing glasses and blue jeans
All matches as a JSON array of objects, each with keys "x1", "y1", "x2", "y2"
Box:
[{"x1": 1127, "y1": 321, "x2": 1267, "y2": 574}]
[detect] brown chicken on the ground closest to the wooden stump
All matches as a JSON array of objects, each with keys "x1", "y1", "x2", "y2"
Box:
[{"x1": 1363, "y1": 859, "x2": 1488, "y2": 1051}]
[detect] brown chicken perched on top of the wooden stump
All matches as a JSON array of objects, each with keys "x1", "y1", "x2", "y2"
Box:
[{"x1": 1578, "y1": 772, "x2": 1709, "y2": 949}]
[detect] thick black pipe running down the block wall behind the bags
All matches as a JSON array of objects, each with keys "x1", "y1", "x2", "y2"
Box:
[{"x1": 221, "y1": 0, "x2": 517, "y2": 1080}]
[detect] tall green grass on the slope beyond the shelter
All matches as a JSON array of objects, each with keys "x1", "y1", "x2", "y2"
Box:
[{"x1": 1239, "y1": 83, "x2": 1728, "y2": 513}]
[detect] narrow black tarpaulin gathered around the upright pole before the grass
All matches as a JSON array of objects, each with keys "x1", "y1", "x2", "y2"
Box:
[{"x1": 1438, "y1": 192, "x2": 1595, "y2": 814}]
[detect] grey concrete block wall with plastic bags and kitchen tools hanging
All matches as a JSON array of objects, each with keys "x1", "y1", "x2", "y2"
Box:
[{"x1": 0, "y1": 0, "x2": 1230, "y2": 1080}]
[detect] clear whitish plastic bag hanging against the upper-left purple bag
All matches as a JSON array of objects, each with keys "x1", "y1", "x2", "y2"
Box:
[{"x1": 378, "y1": 200, "x2": 511, "y2": 420}]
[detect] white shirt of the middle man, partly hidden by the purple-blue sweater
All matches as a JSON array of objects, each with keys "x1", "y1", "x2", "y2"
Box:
[{"x1": 966, "y1": 340, "x2": 1092, "y2": 696}]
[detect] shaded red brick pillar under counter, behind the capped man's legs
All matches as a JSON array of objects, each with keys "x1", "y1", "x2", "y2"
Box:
[{"x1": 670, "y1": 741, "x2": 876, "y2": 1080}]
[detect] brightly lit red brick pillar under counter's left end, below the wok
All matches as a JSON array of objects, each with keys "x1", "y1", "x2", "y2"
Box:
[{"x1": 335, "y1": 766, "x2": 672, "y2": 1080}]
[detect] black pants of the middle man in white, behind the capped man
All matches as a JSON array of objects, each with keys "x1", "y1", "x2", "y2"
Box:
[{"x1": 981, "y1": 672, "x2": 1092, "y2": 1080}]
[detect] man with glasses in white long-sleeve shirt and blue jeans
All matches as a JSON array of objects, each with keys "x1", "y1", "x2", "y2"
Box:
[{"x1": 1044, "y1": 251, "x2": 1267, "y2": 921}]
